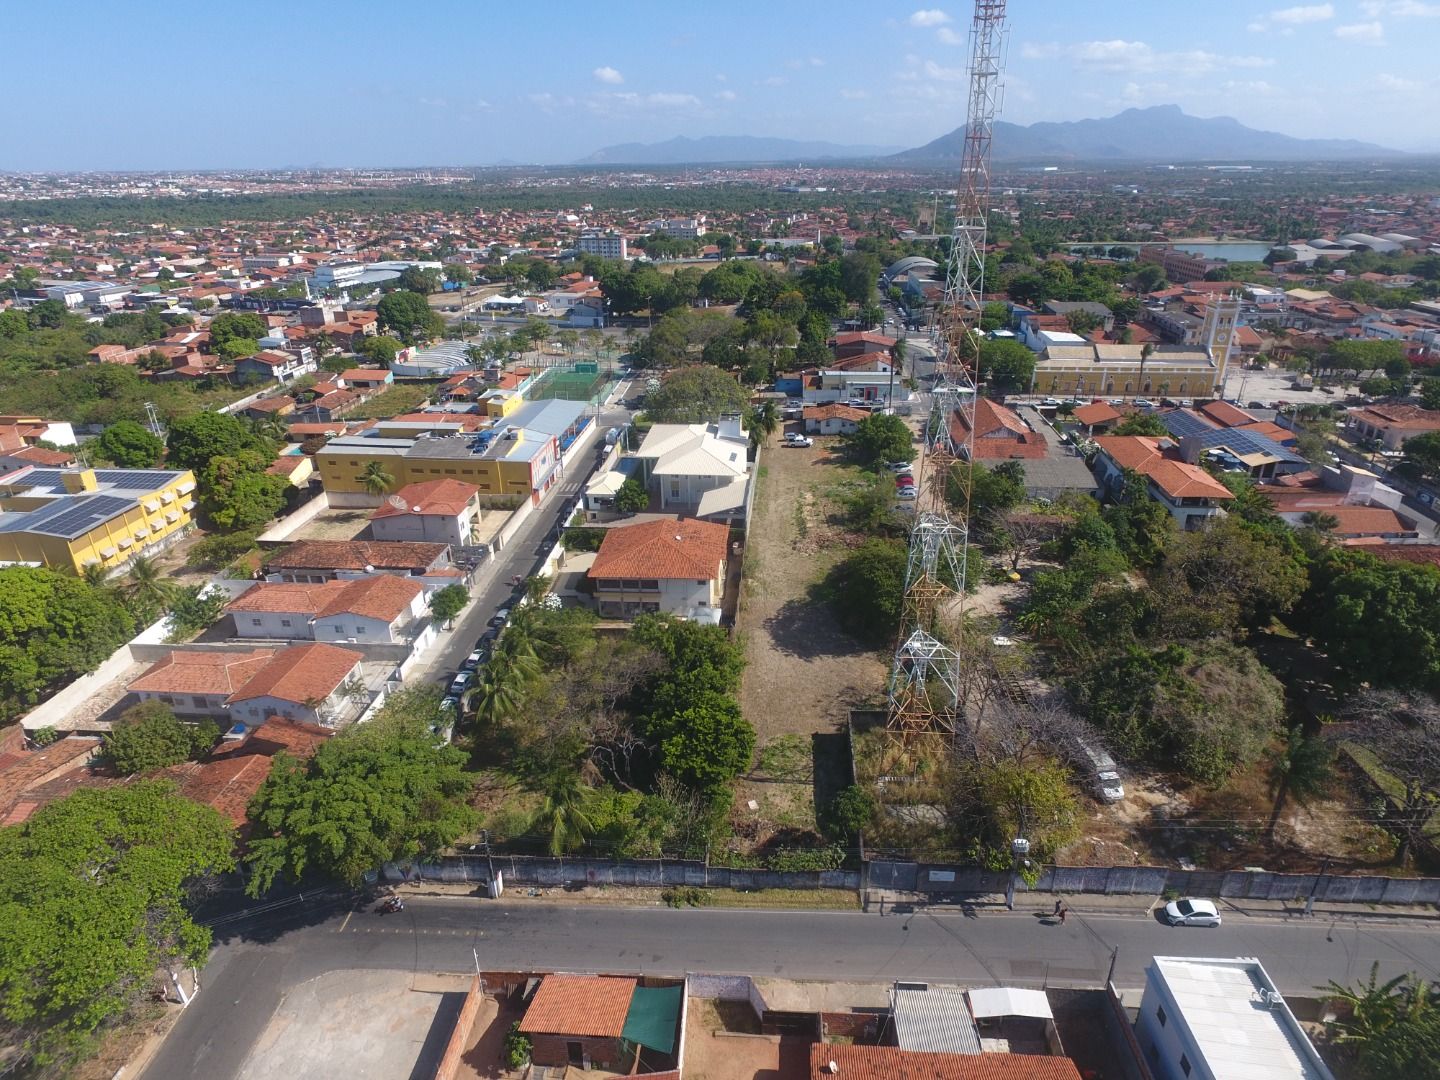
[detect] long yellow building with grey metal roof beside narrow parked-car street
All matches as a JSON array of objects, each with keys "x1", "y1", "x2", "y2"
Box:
[{"x1": 315, "y1": 399, "x2": 590, "y2": 507}]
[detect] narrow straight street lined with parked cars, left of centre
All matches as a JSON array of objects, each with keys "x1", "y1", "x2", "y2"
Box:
[{"x1": 422, "y1": 397, "x2": 631, "y2": 683}]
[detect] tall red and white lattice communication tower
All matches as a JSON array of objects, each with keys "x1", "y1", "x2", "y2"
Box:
[{"x1": 887, "y1": 0, "x2": 1005, "y2": 739}]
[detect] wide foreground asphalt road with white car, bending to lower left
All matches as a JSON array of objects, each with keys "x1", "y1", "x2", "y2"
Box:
[{"x1": 144, "y1": 897, "x2": 1440, "y2": 1080}]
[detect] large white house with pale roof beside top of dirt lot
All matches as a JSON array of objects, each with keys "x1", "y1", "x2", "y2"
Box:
[{"x1": 635, "y1": 419, "x2": 750, "y2": 520}]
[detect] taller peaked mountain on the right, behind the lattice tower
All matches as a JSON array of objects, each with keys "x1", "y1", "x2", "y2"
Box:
[{"x1": 890, "y1": 105, "x2": 1401, "y2": 163}]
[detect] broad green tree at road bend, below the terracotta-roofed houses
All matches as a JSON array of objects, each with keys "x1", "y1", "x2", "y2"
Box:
[{"x1": 245, "y1": 704, "x2": 478, "y2": 896}]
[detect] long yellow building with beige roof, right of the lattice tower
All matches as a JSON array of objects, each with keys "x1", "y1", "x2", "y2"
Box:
[{"x1": 1031, "y1": 344, "x2": 1221, "y2": 397}]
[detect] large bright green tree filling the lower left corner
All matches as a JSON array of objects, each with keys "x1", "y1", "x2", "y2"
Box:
[{"x1": 0, "y1": 780, "x2": 233, "y2": 1066}]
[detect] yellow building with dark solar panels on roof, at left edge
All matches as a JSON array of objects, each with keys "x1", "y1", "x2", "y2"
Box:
[{"x1": 0, "y1": 468, "x2": 194, "y2": 573}]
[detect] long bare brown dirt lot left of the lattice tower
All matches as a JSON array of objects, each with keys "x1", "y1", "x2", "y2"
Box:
[{"x1": 736, "y1": 438, "x2": 887, "y2": 847}]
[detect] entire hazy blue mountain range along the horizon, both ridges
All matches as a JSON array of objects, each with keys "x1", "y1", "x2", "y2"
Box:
[{"x1": 575, "y1": 105, "x2": 1401, "y2": 166}]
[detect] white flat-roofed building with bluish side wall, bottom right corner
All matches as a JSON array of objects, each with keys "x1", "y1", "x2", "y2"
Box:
[{"x1": 1135, "y1": 956, "x2": 1333, "y2": 1080}]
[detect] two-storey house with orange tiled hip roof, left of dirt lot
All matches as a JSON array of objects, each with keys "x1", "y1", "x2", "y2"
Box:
[{"x1": 588, "y1": 518, "x2": 730, "y2": 624}]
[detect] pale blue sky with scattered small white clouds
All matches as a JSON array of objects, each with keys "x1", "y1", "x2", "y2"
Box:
[{"x1": 0, "y1": 0, "x2": 1440, "y2": 171}]
